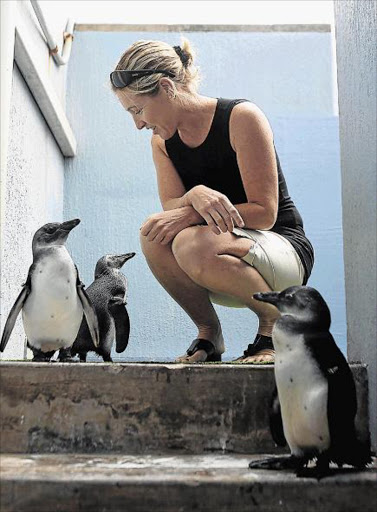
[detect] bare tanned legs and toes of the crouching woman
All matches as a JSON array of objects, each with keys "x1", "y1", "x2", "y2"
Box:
[{"x1": 142, "y1": 226, "x2": 278, "y2": 362}]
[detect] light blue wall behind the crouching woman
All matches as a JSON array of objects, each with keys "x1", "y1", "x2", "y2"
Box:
[{"x1": 64, "y1": 32, "x2": 346, "y2": 361}]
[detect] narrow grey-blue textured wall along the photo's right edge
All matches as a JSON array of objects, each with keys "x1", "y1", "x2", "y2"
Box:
[{"x1": 335, "y1": 0, "x2": 377, "y2": 447}]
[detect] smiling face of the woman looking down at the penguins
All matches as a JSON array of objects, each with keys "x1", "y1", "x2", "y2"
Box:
[{"x1": 116, "y1": 87, "x2": 177, "y2": 140}]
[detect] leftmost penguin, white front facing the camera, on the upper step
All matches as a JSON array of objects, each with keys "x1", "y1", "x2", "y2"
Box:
[{"x1": 0, "y1": 219, "x2": 99, "y2": 362}]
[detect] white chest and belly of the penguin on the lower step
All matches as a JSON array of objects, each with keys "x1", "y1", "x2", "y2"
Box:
[{"x1": 274, "y1": 329, "x2": 330, "y2": 456}]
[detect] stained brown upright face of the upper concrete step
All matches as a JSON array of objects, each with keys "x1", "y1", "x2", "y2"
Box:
[{"x1": 0, "y1": 362, "x2": 368, "y2": 454}]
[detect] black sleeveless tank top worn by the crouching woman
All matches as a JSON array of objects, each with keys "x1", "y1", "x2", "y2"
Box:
[{"x1": 165, "y1": 98, "x2": 314, "y2": 284}]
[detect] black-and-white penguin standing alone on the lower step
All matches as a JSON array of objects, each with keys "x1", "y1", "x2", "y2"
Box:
[{"x1": 249, "y1": 286, "x2": 372, "y2": 478}]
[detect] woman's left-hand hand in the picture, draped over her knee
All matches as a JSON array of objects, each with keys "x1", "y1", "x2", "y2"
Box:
[{"x1": 140, "y1": 206, "x2": 203, "y2": 245}]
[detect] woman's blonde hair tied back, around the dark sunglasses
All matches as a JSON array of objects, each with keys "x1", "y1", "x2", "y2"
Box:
[{"x1": 112, "y1": 38, "x2": 200, "y2": 96}]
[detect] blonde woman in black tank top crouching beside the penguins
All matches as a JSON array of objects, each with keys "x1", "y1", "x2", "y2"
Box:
[{"x1": 110, "y1": 40, "x2": 313, "y2": 364}]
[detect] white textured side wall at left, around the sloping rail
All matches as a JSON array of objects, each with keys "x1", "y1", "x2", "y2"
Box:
[{"x1": 0, "y1": 2, "x2": 66, "y2": 359}]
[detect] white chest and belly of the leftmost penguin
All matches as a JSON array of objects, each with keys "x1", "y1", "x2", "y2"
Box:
[{"x1": 22, "y1": 247, "x2": 83, "y2": 352}]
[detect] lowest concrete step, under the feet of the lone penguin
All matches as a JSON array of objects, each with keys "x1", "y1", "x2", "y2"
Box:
[{"x1": 0, "y1": 454, "x2": 377, "y2": 512}]
